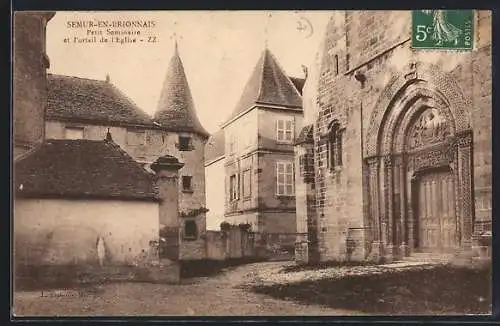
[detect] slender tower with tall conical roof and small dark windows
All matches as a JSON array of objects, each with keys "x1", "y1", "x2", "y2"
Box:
[{"x1": 154, "y1": 43, "x2": 209, "y2": 260}]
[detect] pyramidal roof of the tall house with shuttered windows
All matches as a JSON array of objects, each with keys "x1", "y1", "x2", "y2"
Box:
[{"x1": 229, "y1": 48, "x2": 302, "y2": 120}]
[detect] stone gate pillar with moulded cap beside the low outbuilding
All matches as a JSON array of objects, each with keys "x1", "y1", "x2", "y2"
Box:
[{"x1": 151, "y1": 155, "x2": 184, "y2": 262}]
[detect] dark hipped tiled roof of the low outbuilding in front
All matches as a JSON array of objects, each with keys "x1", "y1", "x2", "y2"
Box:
[{"x1": 14, "y1": 140, "x2": 157, "y2": 200}]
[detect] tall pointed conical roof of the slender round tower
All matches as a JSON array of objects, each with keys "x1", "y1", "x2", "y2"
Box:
[{"x1": 154, "y1": 44, "x2": 209, "y2": 137}]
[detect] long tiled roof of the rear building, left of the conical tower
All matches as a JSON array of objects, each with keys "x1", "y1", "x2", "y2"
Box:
[{"x1": 46, "y1": 74, "x2": 153, "y2": 126}]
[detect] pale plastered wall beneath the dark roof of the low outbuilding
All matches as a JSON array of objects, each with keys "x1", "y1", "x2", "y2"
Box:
[{"x1": 14, "y1": 199, "x2": 159, "y2": 265}]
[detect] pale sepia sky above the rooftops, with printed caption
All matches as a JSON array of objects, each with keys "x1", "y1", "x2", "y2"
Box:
[{"x1": 47, "y1": 11, "x2": 332, "y2": 133}]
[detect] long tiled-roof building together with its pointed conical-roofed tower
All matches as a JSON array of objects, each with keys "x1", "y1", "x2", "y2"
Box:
[{"x1": 45, "y1": 44, "x2": 208, "y2": 260}]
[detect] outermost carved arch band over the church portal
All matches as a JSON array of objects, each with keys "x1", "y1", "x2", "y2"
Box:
[{"x1": 365, "y1": 62, "x2": 472, "y2": 156}]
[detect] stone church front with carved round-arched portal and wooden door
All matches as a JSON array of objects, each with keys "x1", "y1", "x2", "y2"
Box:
[{"x1": 295, "y1": 11, "x2": 492, "y2": 261}]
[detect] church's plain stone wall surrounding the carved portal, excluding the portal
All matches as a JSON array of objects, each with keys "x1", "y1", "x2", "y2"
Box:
[{"x1": 315, "y1": 11, "x2": 491, "y2": 260}]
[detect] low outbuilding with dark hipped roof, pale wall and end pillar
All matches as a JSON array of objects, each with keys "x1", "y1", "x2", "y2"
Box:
[{"x1": 14, "y1": 134, "x2": 182, "y2": 281}]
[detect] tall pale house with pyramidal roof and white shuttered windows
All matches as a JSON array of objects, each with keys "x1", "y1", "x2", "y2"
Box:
[{"x1": 205, "y1": 47, "x2": 304, "y2": 258}]
